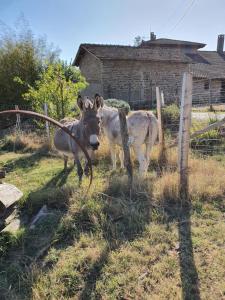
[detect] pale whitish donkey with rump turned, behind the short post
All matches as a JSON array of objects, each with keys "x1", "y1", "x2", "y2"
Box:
[{"x1": 99, "y1": 95, "x2": 158, "y2": 175}]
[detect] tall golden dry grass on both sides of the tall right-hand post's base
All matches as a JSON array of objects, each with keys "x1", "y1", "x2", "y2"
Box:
[{"x1": 154, "y1": 153, "x2": 225, "y2": 206}]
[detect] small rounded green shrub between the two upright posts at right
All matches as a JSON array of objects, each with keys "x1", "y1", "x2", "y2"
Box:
[{"x1": 162, "y1": 104, "x2": 180, "y2": 131}]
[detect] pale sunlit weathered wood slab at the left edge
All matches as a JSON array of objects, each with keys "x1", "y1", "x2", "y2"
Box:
[{"x1": 0, "y1": 183, "x2": 23, "y2": 216}]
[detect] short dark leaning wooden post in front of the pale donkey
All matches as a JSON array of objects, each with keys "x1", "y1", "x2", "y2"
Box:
[{"x1": 118, "y1": 108, "x2": 133, "y2": 189}]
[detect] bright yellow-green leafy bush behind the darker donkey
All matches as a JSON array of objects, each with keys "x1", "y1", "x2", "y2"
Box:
[{"x1": 23, "y1": 61, "x2": 87, "y2": 120}]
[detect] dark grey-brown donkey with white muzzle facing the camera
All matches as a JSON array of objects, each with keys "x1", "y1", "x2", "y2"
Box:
[{"x1": 54, "y1": 96, "x2": 103, "y2": 182}]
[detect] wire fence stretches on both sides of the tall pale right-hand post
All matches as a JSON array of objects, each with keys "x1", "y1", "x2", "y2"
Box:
[{"x1": 152, "y1": 70, "x2": 225, "y2": 155}]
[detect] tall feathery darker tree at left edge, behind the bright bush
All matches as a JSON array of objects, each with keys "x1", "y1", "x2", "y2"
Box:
[{"x1": 0, "y1": 18, "x2": 59, "y2": 108}]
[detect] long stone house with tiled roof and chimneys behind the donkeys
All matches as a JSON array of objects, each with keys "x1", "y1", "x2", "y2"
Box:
[{"x1": 73, "y1": 33, "x2": 225, "y2": 108}]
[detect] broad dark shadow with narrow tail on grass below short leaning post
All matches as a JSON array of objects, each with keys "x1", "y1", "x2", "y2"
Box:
[{"x1": 79, "y1": 178, "x2": 151, "y2": 300}]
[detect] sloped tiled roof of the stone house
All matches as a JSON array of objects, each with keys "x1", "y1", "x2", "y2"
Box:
[{"x1": 73, "y1": 39, "x2": 225, "y2": 78}]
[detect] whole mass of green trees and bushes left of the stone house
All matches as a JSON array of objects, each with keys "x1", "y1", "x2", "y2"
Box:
[{"x1": 0, "y1": 18, "x2": 87, "y2": 122}]
